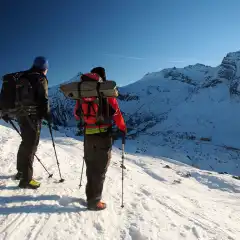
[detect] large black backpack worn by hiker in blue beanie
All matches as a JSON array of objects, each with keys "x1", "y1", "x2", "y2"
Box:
[{"x1": 0, "y1": 72, "x2": 41, "y2": 118}]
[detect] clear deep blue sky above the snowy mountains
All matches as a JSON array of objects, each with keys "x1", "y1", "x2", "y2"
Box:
[{"x1": 0, "y1": 0, "x2": 240, "y2": 85}]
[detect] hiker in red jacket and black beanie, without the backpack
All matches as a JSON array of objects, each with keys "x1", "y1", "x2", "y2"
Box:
[{"x1": 74, "y1": 67, "x2": 126, "y2": 210}]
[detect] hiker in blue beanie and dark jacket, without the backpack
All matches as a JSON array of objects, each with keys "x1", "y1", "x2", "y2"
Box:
[{"x1": 16, "y1": 57, "x2": 51, "y2": 189}]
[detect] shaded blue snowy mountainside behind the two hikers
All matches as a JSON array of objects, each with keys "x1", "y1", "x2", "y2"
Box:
[{"x1": 50, "y1": 52, "x2": 240, "y2": 175}]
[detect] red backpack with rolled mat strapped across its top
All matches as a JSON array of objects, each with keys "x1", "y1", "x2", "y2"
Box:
[{"x1": 60, "y1": 73, "x2": 118, "y2": 130}]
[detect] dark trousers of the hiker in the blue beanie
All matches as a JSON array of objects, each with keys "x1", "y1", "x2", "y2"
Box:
[{"x1": 17, "y1": 117, "x2": 41, "y2": 182}]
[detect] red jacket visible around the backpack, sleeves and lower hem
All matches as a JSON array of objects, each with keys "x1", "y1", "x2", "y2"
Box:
[{"x1": 74, "y1": 97, "x2": 126, "y2": 132}]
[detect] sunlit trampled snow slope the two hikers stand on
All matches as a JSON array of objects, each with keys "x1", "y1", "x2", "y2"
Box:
[{"x1": 0, "y1": 122, "x2": 240, "y2": 240}]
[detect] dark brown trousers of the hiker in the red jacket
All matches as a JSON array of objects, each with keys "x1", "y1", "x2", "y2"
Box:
[{"x1": 84, "y1": 133, "x2": 112, "y2": 204}]
